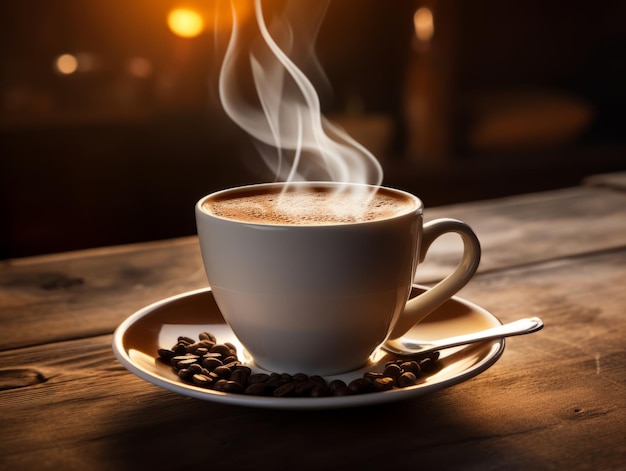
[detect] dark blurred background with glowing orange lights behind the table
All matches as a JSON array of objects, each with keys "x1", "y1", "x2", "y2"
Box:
[{"x1": 0, "y1": 0, "x2": 626, "y2": 258}]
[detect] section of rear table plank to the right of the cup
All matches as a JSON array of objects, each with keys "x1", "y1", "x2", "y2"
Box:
[{"x1": 417, "y1": 187, "x2": 626, "y2": 282}]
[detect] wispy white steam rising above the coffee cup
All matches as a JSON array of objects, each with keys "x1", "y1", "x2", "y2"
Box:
[{"x1": 219, "y1": 0, "x2": 382, "y2": 194}]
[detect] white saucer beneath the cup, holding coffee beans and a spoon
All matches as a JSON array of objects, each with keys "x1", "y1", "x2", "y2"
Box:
[{"x1": 113, "y1": 286, "x2": 505, "y2": 409}]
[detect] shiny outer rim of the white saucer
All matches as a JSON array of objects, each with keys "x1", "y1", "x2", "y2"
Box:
[{"x1": 112, "y1": 284, "x2": 506, "y2": 410}]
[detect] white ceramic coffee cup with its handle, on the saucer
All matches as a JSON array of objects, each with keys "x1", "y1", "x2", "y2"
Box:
[{"x1": 196, "y1": 182, "x2": 480, "y2": 375}]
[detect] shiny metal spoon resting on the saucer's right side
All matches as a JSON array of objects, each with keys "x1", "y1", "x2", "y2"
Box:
[{"x1": 382, "y1": 317, "x2": 543, "y2": 356}]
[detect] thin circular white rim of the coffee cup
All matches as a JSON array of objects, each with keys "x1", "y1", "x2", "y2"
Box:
[{"x1": 196, "y1": 181, "x2": 424, "y2": 228}]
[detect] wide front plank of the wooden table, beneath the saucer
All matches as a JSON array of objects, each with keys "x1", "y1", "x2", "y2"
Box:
[{"x1": 0, "y1": 249, "x2": 626, "y2": 470}]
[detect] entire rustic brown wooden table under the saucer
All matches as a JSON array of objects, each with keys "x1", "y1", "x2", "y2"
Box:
[{"x1": 0, "y1": 176, "x2": 626, "y2": 471}]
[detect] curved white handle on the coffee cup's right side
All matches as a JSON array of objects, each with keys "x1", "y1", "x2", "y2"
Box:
[{"x1": 389, "y1": 219, "x2": 481, "y2": 339}]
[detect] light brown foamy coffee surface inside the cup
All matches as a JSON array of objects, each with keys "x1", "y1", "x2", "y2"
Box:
[{"x1": 204, "y1": 188, "x2": 416, "y2": 225}]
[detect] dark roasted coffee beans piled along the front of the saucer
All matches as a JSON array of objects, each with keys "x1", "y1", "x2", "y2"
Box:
[{"x1": 158, "y1": 332, "x2": 439, "y2": 397}]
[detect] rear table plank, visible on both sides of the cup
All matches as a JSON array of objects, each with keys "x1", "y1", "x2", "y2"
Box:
[{"x1": 0, "y1": 188, "x2": 626, "y2": 350}]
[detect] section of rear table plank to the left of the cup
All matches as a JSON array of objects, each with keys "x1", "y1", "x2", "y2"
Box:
[{"x1": 0, "y1": 242, "x2": 207, "y2": 350}]
